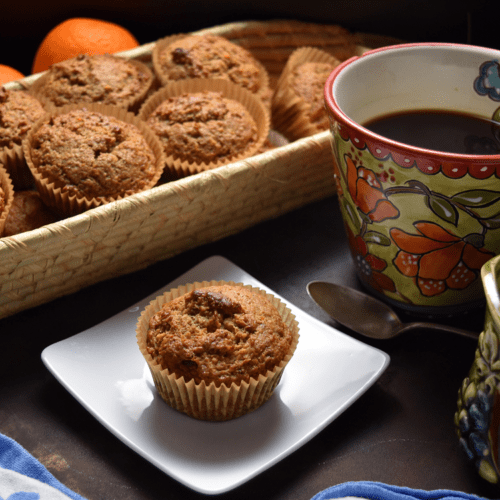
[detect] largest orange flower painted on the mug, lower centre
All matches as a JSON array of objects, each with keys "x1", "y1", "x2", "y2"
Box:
[{"x1": 390, "y1": 222, "x2": 495, "y2": 297}]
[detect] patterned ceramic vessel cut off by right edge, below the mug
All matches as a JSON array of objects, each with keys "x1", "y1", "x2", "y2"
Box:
[{"x1": 455, "y1": 256, "x2": 500, "y2": 484}]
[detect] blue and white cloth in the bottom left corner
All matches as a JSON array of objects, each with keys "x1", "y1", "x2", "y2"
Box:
[{"x1": 0, "y1": 434, "x2": 85, "y2": 500}]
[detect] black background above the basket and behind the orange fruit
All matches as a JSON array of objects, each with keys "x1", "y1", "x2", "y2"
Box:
[{"x1": 0, "y1": 0, "x2": 500, "y2": 75}]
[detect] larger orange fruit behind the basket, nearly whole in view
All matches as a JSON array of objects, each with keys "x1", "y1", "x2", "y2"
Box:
[{"x1": 32, "y1": 17, "x2": 139, "y2": 73}]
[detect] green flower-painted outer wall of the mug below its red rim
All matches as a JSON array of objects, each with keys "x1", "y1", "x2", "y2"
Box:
[{"x1": 333, "y1": 122, "x2": 500, "y2": 307}]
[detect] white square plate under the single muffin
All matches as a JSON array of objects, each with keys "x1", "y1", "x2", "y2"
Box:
[{"x1": 42, "y1": 256, "x2": 389, "y2": 495}]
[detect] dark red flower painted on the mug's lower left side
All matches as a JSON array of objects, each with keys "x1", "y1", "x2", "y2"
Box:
[{"x1": 346, "y1": 226, "x2": 396, "y2": 293}]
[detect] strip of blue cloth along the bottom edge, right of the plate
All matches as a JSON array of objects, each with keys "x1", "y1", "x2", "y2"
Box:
[{"x1": 311, "y1": 481, "x2": 492, "y2": 500}]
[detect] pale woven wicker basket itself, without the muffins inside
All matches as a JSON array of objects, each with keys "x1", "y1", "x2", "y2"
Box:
[{"x1": 0, "y1": 21, "x2": 372, "y2": 318}]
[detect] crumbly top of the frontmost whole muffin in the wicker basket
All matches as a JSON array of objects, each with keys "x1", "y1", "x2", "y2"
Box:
[{"x1": 31, "y1": 109, "x2": 156, "y2": 199}]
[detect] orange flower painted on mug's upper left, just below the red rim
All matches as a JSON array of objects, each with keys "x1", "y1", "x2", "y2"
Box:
[{"x1": 344, "y1": 155, "x2": 399, "y2": 222}]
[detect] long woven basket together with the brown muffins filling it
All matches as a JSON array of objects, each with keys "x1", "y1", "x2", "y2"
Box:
[{"x1": 0, "y1": 21, "x2": 360, "y2": 317}]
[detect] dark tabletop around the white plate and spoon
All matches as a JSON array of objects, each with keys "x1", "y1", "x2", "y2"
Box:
[{"x1": 0, "y1": 194, "x2": 500, "y2": 500}]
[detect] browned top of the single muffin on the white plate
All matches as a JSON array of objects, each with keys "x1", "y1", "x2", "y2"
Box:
[{"x1": 146, "y1": 285, "x2": 292, "y2": 387}]
